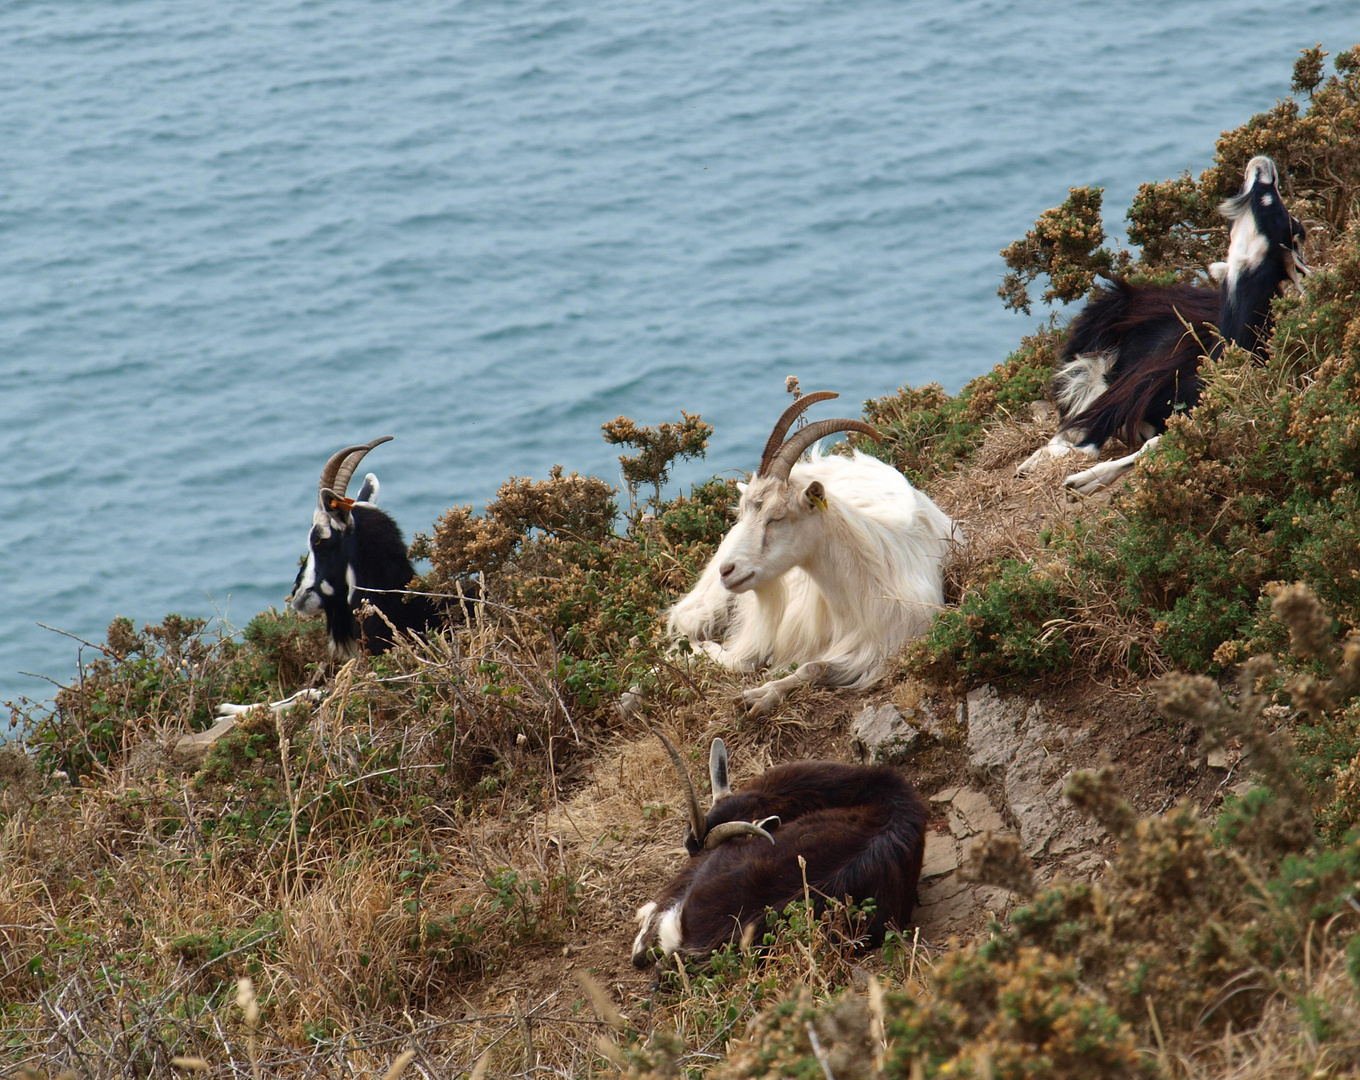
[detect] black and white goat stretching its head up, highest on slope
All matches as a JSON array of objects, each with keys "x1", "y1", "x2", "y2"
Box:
[{"x1": 1017, "y1": 156, "x2": 1308, "y2": 494}]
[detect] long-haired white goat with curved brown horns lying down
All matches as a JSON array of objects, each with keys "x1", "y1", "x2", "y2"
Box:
[{"x1": 668, "y1": 392, "x2": 953, "y2": 715}]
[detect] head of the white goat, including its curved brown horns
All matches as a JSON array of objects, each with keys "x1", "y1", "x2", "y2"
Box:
[{"x1": 718, "y1": 390, "x2": 883, "y2": 593}]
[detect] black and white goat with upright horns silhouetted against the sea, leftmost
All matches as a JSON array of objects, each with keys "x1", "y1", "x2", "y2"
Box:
[{"x1": 288, "y1": 435, "x2": 457, "y2": 656}]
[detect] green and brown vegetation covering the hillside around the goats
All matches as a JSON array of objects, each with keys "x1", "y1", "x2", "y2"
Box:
[{"x1": 0, "y1": 39, "x2": 1360, "y2": 1080}]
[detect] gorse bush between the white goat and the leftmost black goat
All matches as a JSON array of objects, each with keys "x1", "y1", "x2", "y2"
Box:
[{"x1": 412, "y1": 414, "x2": 738, "y2": 711}]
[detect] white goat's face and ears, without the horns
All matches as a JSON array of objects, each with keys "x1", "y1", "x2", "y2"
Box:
[{"x1": 718, "y1": 476, "x2": 827, "y2": 593}]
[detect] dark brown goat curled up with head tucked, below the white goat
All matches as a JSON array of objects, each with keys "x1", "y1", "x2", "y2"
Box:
[{"x1": 632, "y1": 736, "x2": 926, "y2": 967}]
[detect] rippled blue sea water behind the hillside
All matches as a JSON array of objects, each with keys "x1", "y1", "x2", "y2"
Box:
[{"x1": 0, "y1": 0, "x2": 1360, "y2": 699}]
